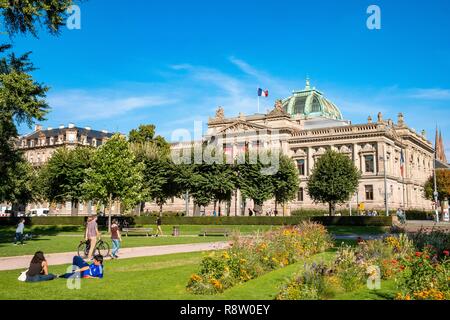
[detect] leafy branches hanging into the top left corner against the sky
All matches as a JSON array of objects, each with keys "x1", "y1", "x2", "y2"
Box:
[{"x1": 0, "y1": 0, "x2": 73, "y2": 37}]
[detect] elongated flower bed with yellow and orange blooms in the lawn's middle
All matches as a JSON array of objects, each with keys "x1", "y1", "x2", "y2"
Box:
[{"x1": 187, "y1": 222, "x2": 332, "y2": 294}]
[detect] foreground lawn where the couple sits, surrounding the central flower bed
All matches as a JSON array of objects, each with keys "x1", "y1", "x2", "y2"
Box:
[{"x1": 0, "y1": 251, "x2": 394, "y2": 300}]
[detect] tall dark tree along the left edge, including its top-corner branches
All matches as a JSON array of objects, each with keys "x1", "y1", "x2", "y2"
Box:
[{"x1": 0, "y1": 0, "x2": 72, "y2": 205}]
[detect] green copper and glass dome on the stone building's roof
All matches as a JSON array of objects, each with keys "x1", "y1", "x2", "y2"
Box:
[{"x1": 283, "y1": 79, "x2": 343, "y2": 120}]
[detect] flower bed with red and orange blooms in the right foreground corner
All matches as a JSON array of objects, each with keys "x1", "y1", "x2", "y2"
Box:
[{"x1": 277, "y1": 233, "x2": 450, "y2": 300}]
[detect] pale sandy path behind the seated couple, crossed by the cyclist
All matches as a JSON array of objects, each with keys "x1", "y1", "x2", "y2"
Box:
[{"x1": 0, "y1": 242, "x2": 229, "y2": 271}]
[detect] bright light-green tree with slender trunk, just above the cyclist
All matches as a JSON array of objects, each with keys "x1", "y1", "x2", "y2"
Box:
[{"x1": 83, "y1": 134, "x2": 144, "y2": 230}]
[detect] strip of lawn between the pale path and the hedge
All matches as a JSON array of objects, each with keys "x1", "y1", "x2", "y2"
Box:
[{"x1": 0, "y1": 225, "x2": 386, "y2": 257}]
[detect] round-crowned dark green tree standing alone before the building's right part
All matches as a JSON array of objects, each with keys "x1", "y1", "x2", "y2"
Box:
[{"x1": 308, "y1": 150, "x2": 361, "y2": 215}]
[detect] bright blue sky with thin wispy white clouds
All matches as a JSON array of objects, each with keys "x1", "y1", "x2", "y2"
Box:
[{"x1": 3, "y1": 0, "x2": 450, "y2": 155}]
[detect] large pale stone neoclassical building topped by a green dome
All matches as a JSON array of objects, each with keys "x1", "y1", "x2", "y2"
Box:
[{"x1": 146, "y1": 80, "x2": 434, "y2": 215}]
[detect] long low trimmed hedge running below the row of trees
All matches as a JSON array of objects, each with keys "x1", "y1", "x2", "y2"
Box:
[{"x1": 0, "y1": 216, "x2": 392, "y2": 227}]
